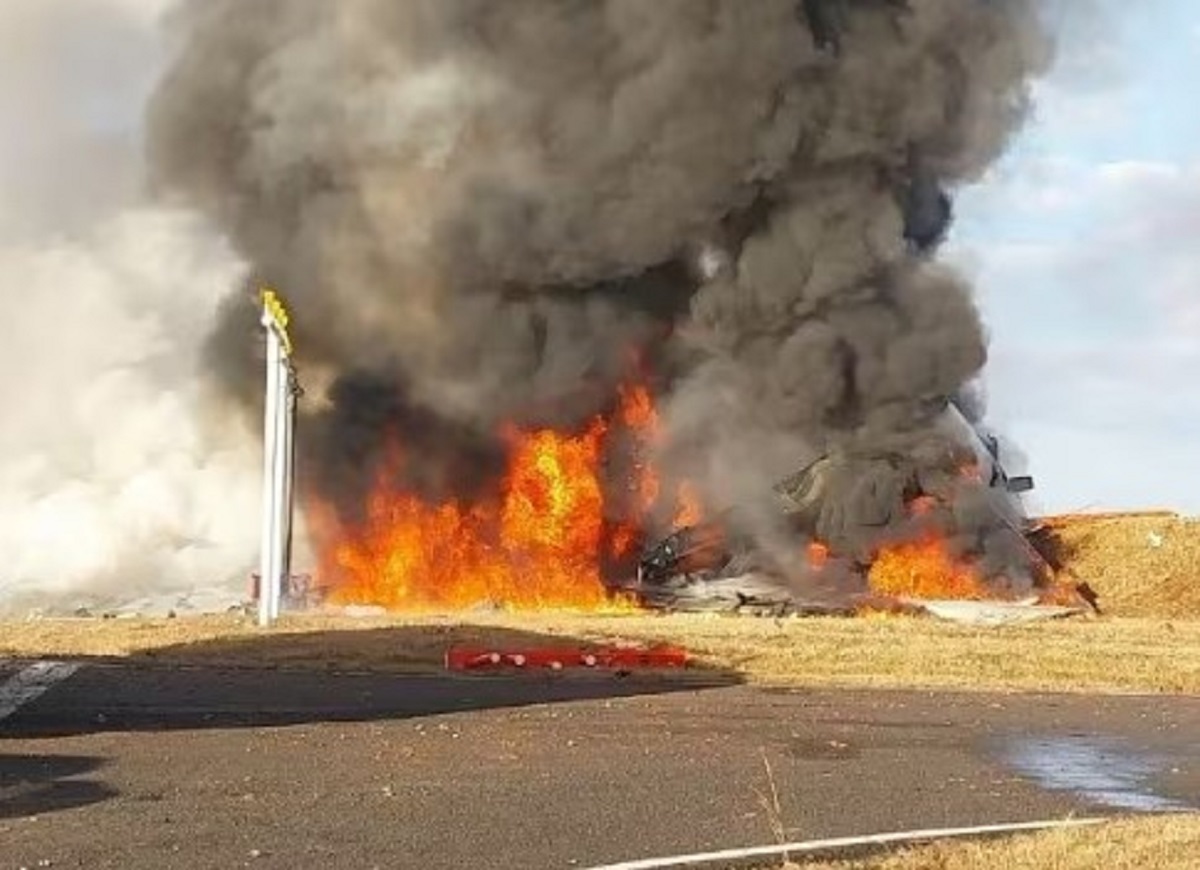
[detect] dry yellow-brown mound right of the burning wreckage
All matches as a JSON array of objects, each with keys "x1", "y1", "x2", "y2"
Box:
[{"x1": 1045, "y1": 511, "x2": 1200, "y2": 619}]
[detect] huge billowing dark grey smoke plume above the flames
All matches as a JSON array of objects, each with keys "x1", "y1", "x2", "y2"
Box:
[{"x1": 150, "y1": 0, "x2": 1049, "y2": 590}]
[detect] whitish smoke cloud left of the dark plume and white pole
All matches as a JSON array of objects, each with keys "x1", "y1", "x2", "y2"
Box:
[{"x1": 0, "y1": 0, "x2": 259, "y2": 610}]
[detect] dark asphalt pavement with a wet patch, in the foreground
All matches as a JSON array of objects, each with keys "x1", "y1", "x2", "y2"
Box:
[{"x1": 0, "y1": 661, "x2": 1200, "y2": 870}]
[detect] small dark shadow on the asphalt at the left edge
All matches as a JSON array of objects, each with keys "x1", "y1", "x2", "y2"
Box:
[{"x1": 0, "y1": 755, "x2": 118, "y2": 818}]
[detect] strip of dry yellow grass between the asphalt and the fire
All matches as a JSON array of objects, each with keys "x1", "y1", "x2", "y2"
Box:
[{"x1": 7, "y1": 613, "x2": 1200, "y2": 694}]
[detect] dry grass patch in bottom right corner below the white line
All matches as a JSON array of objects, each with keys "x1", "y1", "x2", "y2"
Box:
[{"x1": 785, "y1": 815, "x2": 1200, "y2": 870}]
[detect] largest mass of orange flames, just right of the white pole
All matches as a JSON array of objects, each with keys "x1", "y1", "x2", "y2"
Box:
[{"x1": 310, "y1": 385, "x2": 700, "y2": 611}]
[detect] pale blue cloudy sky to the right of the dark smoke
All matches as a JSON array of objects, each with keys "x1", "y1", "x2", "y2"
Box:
[{"x1": 949, "y1": 0, "x2": 1200, "y2": 512}]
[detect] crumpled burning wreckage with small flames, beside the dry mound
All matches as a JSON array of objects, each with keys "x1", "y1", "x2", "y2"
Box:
[{"x1": 629, "y1": 401, "x2": 1099, "y2": 622}]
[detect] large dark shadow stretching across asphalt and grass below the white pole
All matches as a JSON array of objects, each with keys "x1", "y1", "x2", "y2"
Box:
[{"x1": 0, "y1": 625, "x2": 743, "y2": 737}]
